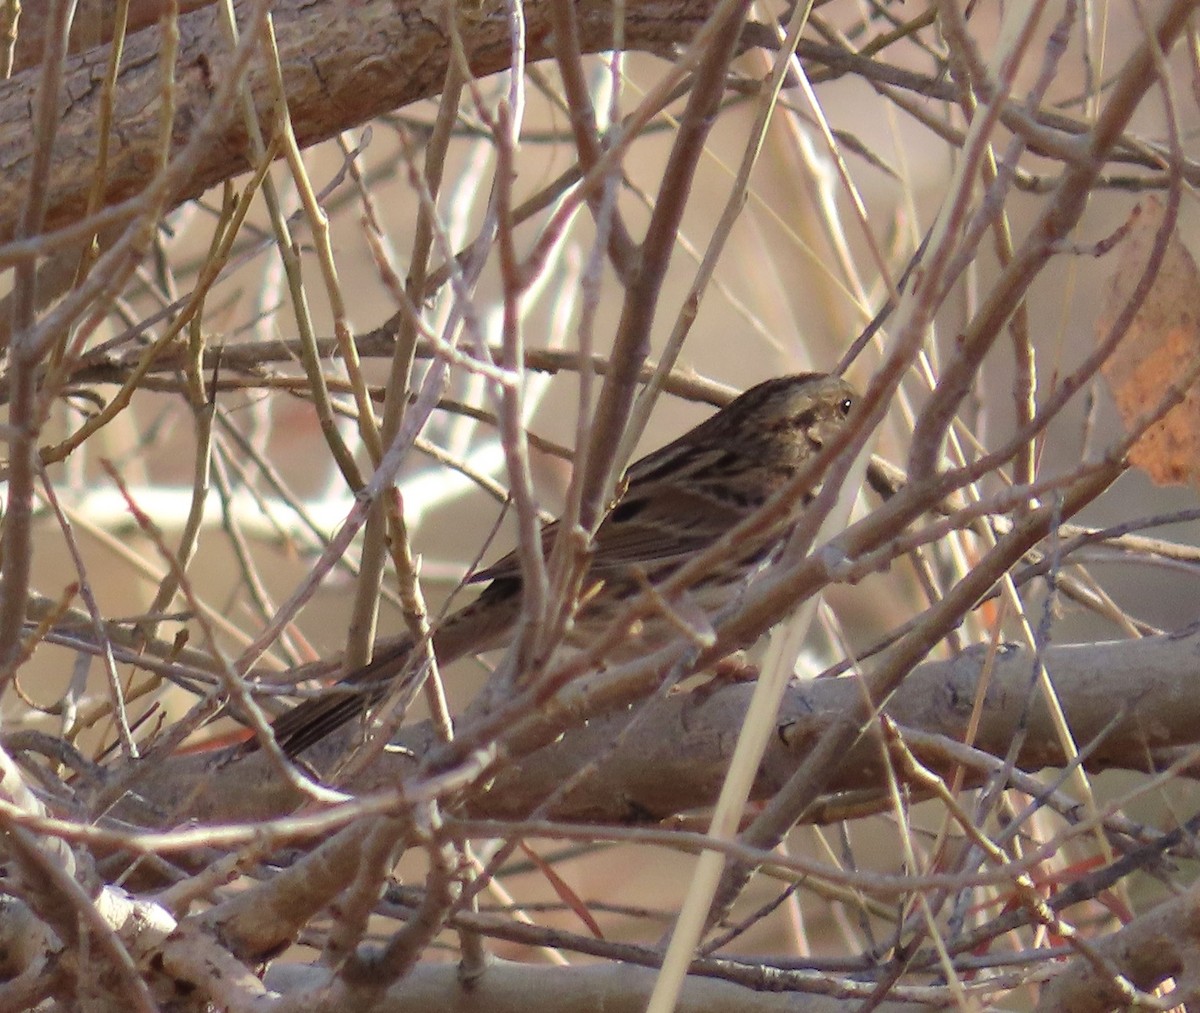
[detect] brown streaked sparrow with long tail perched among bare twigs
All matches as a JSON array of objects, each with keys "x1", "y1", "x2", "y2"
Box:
[{"x1": 265, "y1": 373, "x2": 857, "y2": 756}]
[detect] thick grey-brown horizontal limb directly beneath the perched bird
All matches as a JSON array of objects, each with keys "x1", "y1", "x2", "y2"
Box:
[{"x1": 142, "y1": 629, "x2": 1200, "y2": 822}]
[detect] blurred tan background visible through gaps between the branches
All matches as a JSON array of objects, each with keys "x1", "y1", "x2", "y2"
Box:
[{"x1": 10, "y1": 2, "x2": 1200, "y2": 998}]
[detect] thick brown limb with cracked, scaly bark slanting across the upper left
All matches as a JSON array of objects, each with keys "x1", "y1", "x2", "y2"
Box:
[{"x1": 0, "y1": 0, "x2": 713, "y2": 240}]
